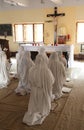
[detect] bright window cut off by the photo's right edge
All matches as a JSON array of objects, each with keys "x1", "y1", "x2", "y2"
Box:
[{"x1": 77, "y1": 22, "x2": 84, "y2": 43}]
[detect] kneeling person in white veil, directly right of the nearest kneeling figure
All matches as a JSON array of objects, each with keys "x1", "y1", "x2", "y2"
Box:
[{"x1": 49, "y1": 52, "x2": 66, "y2": 99}]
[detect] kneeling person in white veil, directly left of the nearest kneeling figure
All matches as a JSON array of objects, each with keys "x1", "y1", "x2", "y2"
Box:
[{"x1": 15, "y1": 51, "x2": 34, "y2": 95}]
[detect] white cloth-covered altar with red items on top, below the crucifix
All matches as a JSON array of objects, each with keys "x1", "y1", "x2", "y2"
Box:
[{"x1": 21, "y1": 44, "x2": 74, "y2": 67}]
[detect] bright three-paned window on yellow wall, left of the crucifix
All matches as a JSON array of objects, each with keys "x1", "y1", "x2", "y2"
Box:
[{"x1": 14, "y1": 23, "x2": 44, "y2": 42}]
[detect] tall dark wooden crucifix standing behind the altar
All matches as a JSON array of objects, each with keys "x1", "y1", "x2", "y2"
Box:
[{"x1": 47, "y1": 7, "x2": 65, "y2": 45}]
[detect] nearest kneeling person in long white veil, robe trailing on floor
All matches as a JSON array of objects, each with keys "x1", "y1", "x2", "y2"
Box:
[{"x1": 23, "y1": 54, "x2": 54, "y2": 126}]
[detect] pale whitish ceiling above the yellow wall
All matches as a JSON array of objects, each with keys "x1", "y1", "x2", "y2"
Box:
[{"x1": 0, "y1": 0, "x2": 84, "y2": 11}]
